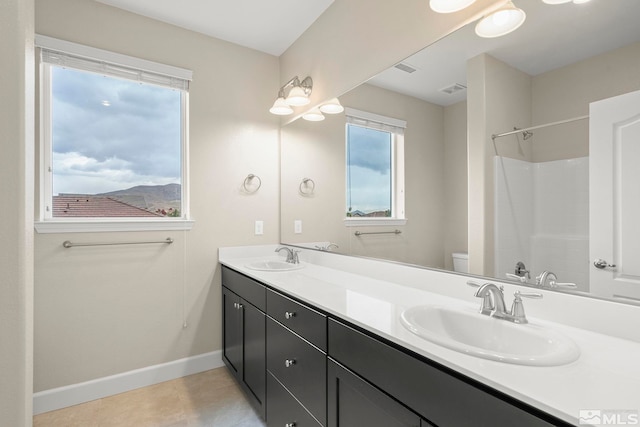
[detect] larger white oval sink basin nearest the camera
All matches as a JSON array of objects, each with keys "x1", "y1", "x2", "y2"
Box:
[{"x1": 400, "y1": 305, "x2": 580, "y2": 366}]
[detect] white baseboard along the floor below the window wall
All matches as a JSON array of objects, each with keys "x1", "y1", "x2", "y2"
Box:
[{"x1": 33, "y1": 350, "x2": 224, "y2": 415}]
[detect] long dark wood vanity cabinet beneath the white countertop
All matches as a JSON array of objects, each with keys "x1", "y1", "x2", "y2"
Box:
[{"x1": 222, "y1": 266, "x2": 571, "y2": 427}]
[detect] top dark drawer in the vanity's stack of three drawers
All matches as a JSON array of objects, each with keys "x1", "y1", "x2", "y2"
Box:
[{"x1": 267, "y1": 289, "x2": 327, "y2": 351}]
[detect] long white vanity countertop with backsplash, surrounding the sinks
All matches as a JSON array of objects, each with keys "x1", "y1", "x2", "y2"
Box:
[{"x1": 219, "y1": 245, "x2": 640, "y2": 425}]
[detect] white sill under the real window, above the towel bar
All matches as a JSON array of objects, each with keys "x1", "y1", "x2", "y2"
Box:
[{"x1": 35, "y1": 219, "x2": 195, "y2": 234}]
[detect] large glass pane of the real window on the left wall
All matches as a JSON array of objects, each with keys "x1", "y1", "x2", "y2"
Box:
[{"x1": 51, "y1": 66, "x2": 182, "y2": 217}]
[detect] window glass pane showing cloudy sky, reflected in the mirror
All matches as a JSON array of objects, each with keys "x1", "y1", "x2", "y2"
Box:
[{"x1": 347, "y1": 124, "x2": 392, "y2": 217}]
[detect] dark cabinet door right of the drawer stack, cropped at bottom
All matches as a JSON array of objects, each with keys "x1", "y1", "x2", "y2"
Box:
[{"x1": 327, "y1": 358, "x2": 422, "y2": 427}]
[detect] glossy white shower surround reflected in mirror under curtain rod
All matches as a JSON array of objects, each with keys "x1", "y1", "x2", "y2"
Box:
[{"x1": 494, "y1": 156, "x2": 589, "y2": 291}]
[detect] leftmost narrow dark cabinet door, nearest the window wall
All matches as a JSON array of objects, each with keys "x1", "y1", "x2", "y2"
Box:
[{"x1": 222, "y1": 286, "x2": 243, "y2": 380}]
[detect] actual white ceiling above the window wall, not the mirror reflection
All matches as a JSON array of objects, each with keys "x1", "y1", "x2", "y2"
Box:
[{"x1": 96, "y1": 0, "x2": 333, "y2": 56}]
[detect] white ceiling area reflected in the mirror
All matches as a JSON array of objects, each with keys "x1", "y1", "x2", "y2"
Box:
[{"x1": 369, "y1": 0, "x2": 640, "y2": 105}]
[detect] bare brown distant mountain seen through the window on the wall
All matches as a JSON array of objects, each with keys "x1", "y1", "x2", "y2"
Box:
[{"x1": 96, "y1": 184, "x2": 182, "y2": 212}]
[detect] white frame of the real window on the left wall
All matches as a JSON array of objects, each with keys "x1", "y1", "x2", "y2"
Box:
[{"x1": 35, "y1": 35, "x2": 194, "y2": 233}]
